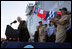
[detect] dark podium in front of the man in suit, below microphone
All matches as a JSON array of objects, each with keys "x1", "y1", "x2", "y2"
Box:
[{"x1": 5, "y1": 25, "x2": 19, "y2": 38}]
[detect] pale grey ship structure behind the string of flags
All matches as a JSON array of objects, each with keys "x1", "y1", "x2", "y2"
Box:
[{"x1": 26, "y1": 1, "x2": 71, "y2": 40}]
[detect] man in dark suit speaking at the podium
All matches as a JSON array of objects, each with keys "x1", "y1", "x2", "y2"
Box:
[{"x1": 17, "y1": 17, "x2": 30, "y2": 42}]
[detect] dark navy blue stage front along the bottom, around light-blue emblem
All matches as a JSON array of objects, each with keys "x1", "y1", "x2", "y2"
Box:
[{"x1": 1, "y1": 42, "x2": 71, "y2": 48}]
